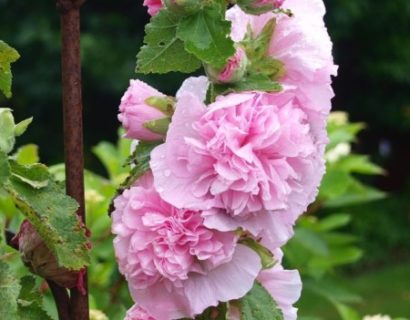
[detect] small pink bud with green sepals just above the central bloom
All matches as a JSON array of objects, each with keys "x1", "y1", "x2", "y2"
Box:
[{"x1": 205, "y1": 48, "x2": 248, "y2": 83}]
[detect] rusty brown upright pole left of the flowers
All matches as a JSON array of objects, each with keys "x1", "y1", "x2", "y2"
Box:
[{"x1": 57, "y1": 0, "x2": 89, "y2": 320}]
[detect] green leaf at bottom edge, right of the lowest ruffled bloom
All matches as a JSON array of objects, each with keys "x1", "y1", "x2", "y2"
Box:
[{"x1": 239, "y1": 282, "x2": 283, "y2": 320}]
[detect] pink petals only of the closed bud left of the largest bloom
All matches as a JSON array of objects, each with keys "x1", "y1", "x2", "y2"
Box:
[{"x1": 118, "y1": 80, "x2": 168, "y2": 141}]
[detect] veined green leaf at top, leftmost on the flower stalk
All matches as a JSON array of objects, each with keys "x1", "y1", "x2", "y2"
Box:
[{"x1": 136, "y1": 9, "x2": 201, "y2": 73}]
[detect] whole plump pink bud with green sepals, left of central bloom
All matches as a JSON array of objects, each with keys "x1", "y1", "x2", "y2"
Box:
[{"x1": 118, "y1": 80, "x2": 173, "y2": 141}]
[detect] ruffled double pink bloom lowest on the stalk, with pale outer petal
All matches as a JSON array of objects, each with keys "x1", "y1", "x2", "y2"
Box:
[{"x1": 112, "y1": 176, "x2": 261, "y2": 320}]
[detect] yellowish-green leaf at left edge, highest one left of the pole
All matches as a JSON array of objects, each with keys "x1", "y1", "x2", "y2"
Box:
[{"x1": 0, "y1": 40, "x2": 20, "y2": 98}]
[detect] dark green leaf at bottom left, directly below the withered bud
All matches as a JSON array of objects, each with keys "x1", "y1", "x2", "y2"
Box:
[{"x1": 18, "y1": 276, "x2": 52, "y2": 320}]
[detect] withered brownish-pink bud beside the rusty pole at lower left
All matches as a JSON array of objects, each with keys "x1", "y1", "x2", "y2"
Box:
[{"x1": 12, "y1": 220, "x2": 85, "y2": 292}]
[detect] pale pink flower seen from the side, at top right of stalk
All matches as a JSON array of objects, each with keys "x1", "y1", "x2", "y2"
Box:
[{"x1": 226, "y1": 0, "x2": 337, "y2": 113}]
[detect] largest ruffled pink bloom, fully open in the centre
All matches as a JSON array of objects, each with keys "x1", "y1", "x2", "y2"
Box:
[{"x1": 150, "y1": 80, "x2": 327, "y2": 246}]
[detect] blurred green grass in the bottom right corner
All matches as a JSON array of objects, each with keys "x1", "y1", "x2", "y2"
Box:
[{"x1": 298, "y1": 263, "x2": 410, "y2": 320}]
